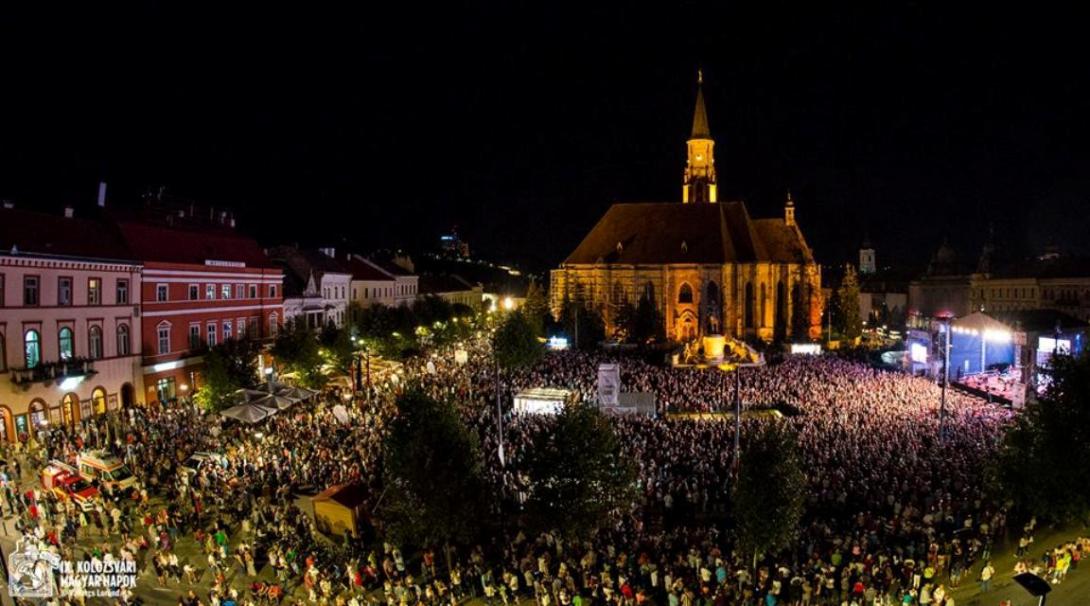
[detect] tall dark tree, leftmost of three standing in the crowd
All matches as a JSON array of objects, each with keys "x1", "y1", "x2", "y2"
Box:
[{"x1": 382, "y1": 388, "x2": 484, "y2": 568}]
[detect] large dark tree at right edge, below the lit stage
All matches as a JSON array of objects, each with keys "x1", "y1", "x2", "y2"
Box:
[{"x1": 994, "y1": 353, "x2": 1090, "y2": 522}]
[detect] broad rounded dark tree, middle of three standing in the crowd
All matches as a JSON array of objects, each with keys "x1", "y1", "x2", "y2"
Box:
[{"x1": 522, "y1": 403, "x2": 637, "y2": 538}]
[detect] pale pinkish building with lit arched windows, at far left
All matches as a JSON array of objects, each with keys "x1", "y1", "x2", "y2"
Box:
[{"x1": 0, "y1": 209, "x2": 144, "y2": 443}]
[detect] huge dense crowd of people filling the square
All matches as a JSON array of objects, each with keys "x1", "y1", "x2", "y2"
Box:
[{"x1": 0, "y1": 337, "x2": 1076, "y2": 606}]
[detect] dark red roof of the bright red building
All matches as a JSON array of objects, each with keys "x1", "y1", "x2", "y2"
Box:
[{"x1": 119, "y1": 221, "x2": 275, "y2": 268}]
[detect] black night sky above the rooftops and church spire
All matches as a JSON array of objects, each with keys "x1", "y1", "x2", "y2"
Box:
[{"x1": 0, "y1": 1, "x2": 1090, "y2": 268}]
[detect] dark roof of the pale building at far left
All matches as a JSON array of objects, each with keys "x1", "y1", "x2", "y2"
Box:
[{"x1": 0, "y1": 208, "x2": 136, "y2": 260}]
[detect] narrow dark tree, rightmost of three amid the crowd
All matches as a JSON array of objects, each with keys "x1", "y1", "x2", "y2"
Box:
[{"x1": 734, "y1": 421, "x2": 807, "y2": 566}]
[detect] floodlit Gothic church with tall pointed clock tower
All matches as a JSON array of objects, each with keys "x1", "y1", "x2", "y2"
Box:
[{"x1": 549, "y1": 74, "x2": 822, "y2": 342}]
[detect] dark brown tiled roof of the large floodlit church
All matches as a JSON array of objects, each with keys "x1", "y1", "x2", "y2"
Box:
[{"x1": 565, "y1": 202, "x2": 810, "y2": 265}]
